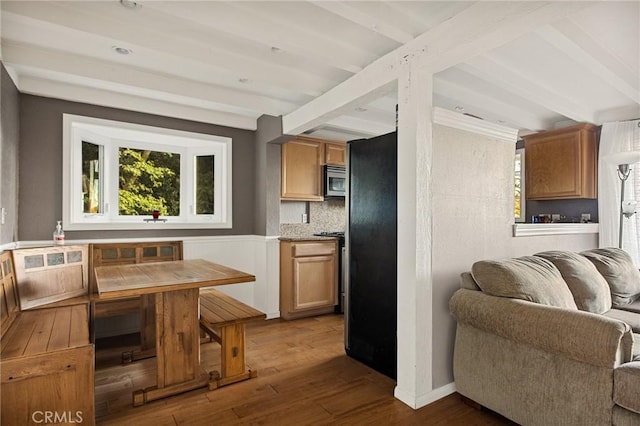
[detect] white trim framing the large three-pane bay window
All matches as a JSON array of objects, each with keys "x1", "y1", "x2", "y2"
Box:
[{"x1": 62, "y1": 114, "x2": 233, "y2": 231}]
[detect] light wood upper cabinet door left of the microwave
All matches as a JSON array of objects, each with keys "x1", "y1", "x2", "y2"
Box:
[{"x1": 281, "y1": 140, "x2": 324, "y2": 201}]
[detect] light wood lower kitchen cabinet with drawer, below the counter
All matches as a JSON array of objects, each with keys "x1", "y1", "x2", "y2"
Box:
[{"x1": 280, "y1": 240, "x2": 338, "y2": 319}]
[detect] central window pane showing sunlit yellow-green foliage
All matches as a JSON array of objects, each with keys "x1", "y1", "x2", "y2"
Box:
[{"x1": 118, "y1": 148, "x2": 180, "y2": 216}]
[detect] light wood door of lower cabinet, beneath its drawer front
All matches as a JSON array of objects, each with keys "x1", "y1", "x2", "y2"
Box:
[{"x1": 293, "y1": 256, "x2": 336, "y2": 311}]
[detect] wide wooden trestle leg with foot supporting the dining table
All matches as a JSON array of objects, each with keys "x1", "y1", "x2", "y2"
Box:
[{"x1": 133, "y1": 288, "x2": 209, "y2": 406}]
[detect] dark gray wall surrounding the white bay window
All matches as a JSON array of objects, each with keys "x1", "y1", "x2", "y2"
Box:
[{"x1": 16, "y1": 94, "x2": 255, "y2": 241}]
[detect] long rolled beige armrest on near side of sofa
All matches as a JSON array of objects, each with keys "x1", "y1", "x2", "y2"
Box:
[{"x1": 449, "y1": 289, "x2": 633, "y2": 367}]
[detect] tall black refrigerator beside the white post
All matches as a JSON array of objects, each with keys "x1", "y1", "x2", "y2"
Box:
[{"x1": 345, "y1": 132, "x2": 398, "y2": 379}]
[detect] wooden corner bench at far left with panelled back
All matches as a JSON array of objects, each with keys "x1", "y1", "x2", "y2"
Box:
[{"x1": 0, "y1": 251, "x2": 95, "y2": 425}]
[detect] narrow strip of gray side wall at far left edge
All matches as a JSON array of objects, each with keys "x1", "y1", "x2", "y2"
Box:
[{"x1": 0, "y1": 65, "x2": 20, "y2": 244}]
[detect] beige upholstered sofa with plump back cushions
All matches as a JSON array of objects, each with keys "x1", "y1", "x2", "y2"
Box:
[{"x1": 450, "y1": 249, "x2": 640, "y2": 426}]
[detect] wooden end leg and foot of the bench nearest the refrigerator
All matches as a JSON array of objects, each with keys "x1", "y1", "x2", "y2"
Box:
[{"x1": 209, "y1": 324, "x2": 258, "y2": 390}]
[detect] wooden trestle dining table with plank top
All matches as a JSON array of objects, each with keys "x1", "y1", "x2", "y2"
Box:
[{"x1": 95, "y1": 259, "x2": 255, "y2": 406}]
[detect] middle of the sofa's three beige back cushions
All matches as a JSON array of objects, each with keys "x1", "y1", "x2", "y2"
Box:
[{"x1": 536, "y1": 251, "x2": 611, "y2": 314}]
